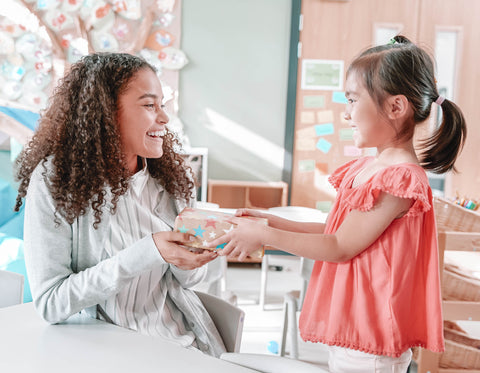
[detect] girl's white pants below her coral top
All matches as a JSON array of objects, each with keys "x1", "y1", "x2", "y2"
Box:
[{"x1": 327, "y1": 346, "x2": 412, "y2": 373}]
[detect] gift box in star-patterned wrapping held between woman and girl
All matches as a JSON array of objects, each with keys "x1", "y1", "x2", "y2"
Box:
[{"x1": 174, "y1": 207, "x2": 268, "y2": 259}]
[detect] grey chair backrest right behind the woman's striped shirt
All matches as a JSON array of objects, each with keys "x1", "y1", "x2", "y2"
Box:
[{"x1": 195, "y1": 291, "x2": 245, "y2": 352}]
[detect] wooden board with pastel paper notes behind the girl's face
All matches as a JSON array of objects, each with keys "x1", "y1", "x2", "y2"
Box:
[{"x1": 290, "y1": 0, "x2": 417, "y2": 212}]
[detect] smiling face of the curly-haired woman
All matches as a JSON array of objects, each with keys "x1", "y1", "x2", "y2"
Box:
[{"x1": 117, "y1": 68, "x2": 168, "y2": 173}]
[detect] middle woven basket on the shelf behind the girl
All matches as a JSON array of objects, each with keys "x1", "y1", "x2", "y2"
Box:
[{"x1": 442, "y1": 263, "x2": 480, "y2": 302}]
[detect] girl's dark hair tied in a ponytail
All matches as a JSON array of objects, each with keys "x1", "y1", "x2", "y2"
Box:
[{"x1": 347, "y1": 35, "x2": 467, "y2": 173}]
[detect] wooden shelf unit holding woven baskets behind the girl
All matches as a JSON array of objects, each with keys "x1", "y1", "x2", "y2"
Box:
[{"x1": 414, "y1": 198, "x2": 480, "y2": 373}]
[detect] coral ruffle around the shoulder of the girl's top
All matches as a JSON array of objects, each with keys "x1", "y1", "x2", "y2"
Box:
[{"x1": 344, "y1": 165, "x2": 432, "y2": 216}]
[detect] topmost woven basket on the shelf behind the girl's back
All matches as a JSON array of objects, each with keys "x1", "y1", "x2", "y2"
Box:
[{"x1": 433, "y1": 197, "x2": 480, "y2": 232}]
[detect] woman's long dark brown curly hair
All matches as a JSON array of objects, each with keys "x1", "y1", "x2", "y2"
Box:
[{"x1": 15, "y1": 53, "x2": 194, "y2": 227}]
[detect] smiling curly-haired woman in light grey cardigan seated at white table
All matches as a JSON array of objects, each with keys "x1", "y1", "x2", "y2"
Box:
[{"x1": 17, "y1": 53, "x2": 225, "y2": 356}]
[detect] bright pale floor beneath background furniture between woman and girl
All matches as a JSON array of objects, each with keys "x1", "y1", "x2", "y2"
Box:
[{"x1": 226, "y1": 256, "x2": 480, "y2": 373}]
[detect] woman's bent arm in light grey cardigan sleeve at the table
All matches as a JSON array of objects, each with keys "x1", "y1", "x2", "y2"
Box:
[{"x1": 24, "y1": 166, "x2": 172, "y2": 323}]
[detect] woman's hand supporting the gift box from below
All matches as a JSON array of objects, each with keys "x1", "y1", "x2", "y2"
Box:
[{"x1": 152, "y1": 232, "x2": 218, "y2": 270}]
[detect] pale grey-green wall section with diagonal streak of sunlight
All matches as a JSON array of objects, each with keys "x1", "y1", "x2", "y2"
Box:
[{"x1": 178, "y1": 0, "x2": 291, "y2": 181}]
